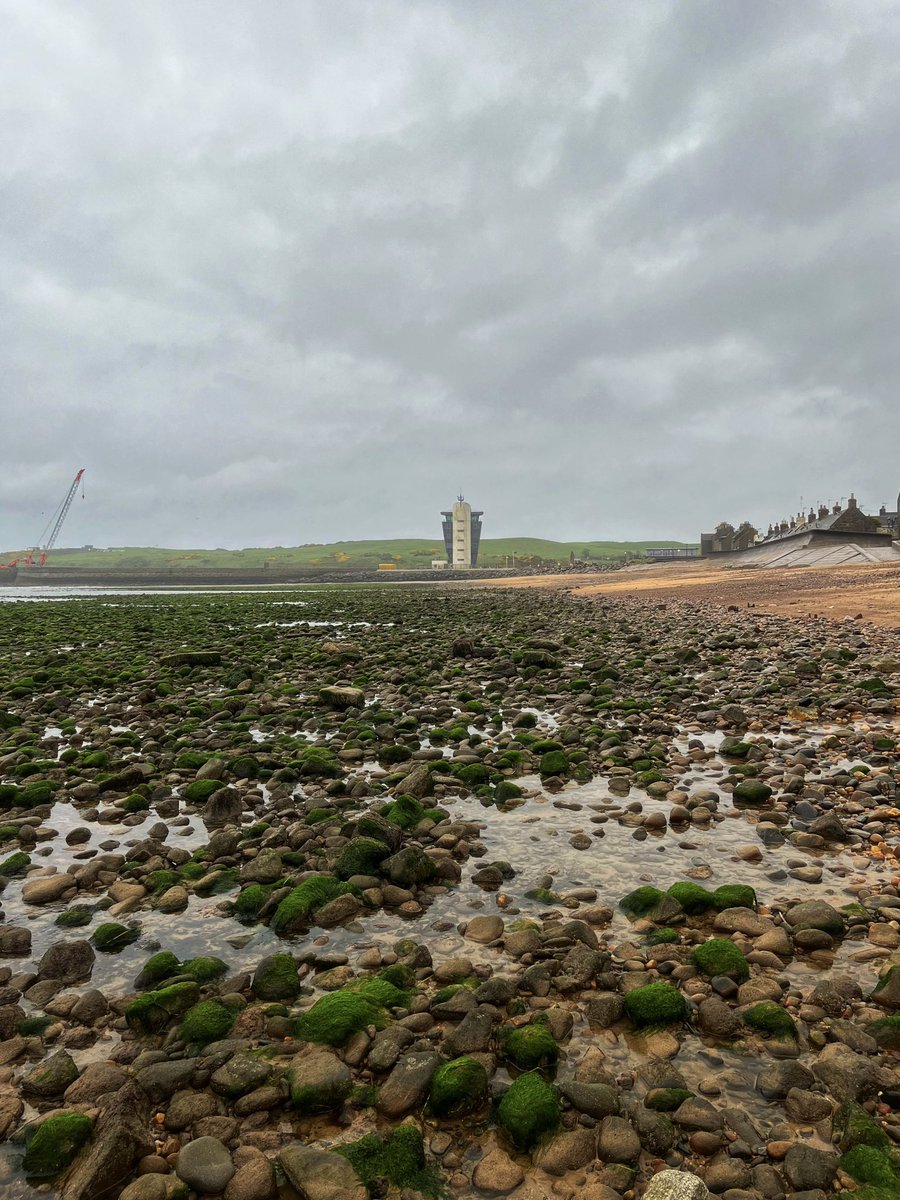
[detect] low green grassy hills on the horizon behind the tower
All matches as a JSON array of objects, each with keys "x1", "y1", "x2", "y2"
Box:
[{"x1": 0, "y1": 538, "x2": 685, "y2": 569}]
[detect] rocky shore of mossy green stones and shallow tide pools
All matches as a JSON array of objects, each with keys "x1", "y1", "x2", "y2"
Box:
[{"x1": 0, "y1": 584, "x2": 900, "y2": 1200}]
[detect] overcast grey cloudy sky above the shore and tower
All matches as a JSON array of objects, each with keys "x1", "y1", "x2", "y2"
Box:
[{"x1": 0, "y1": 0, "x2": 900, "y2": 547}]
